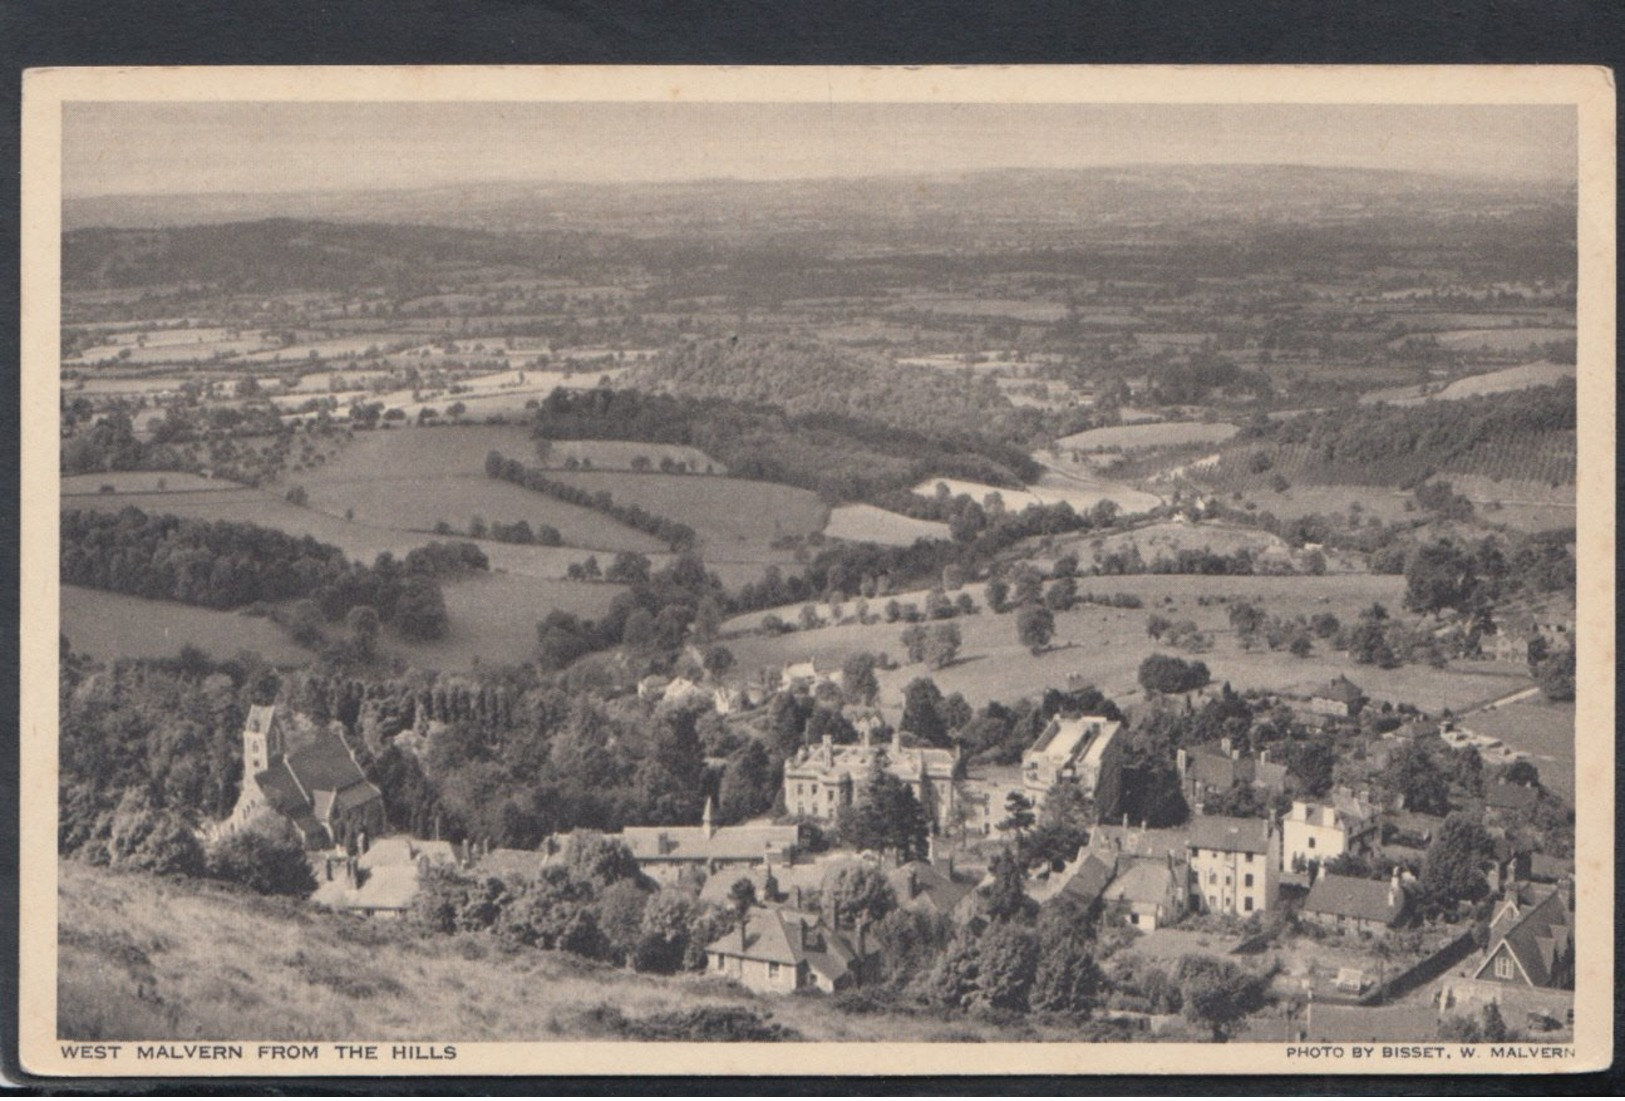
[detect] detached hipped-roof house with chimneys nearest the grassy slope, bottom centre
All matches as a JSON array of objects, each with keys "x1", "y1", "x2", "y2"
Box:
[{"x1": 705, "y1": 906, "x2": 861, "y2": 994}]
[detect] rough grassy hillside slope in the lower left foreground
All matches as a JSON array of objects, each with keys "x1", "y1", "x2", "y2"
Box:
[{"x1": 57, "y1": 861, "x2": 1076, "y2": 1043}]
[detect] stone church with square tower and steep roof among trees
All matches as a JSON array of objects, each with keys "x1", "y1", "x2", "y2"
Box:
[{"x1": 218, "y1": 705, "x2": 385, "y2": 851}]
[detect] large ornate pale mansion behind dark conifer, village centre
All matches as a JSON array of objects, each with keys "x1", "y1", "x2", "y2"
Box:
[{"x1": 785, "y1": 728, "x2": 959, "y2": 831}]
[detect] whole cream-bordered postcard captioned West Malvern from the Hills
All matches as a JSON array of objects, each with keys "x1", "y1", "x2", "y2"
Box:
[{"x1": 23, "y1": 62, "x2": 1614, "y2": 1075}]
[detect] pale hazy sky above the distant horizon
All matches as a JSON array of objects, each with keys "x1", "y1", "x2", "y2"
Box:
[{"x1": 63, "y1": 102, "x2": 1576, "y2": 196}]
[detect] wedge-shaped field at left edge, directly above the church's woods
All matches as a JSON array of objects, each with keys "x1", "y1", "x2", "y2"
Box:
[{"x1": 62, "y1": 585, "x2": 310, "y2": 664}]
